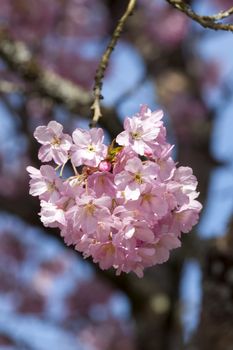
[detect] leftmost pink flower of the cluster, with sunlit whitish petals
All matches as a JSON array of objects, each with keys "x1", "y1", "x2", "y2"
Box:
[{"x1": 27, "y1": 165, "x2": 63, "y2": 202}]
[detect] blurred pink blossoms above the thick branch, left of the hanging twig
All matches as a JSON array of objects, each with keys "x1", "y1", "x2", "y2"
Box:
[{"x1": 0, "y1": 0, "x2": 109, "y2": 89}]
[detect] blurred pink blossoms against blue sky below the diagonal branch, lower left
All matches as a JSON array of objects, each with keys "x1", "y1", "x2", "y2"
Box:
[{"x1": 0, "y1": 228, "x2": 135, "y2": 350}]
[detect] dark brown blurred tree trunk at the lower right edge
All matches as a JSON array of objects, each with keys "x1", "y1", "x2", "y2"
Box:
[{"x1": 190, "y1": 222, "x2": 233, "y2": 350}]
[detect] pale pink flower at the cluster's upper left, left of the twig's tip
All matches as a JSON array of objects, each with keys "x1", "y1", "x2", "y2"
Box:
[{"x1": 34, "y1": 121, "x2": 72, "y2": 165}]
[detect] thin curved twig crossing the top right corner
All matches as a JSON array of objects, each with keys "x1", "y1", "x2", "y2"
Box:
[{"x1": 166, "y1": 0, "x2": 233, "y2": 32}]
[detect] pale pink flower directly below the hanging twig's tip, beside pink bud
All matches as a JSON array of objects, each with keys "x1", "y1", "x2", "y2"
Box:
[{"x1": 71, "y1": 128, "x2": 107, "y2": 167}]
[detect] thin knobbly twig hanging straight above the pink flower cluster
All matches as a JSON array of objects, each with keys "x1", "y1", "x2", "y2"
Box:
[{"x1": 90, "y1": 0, "x2": 137, "y2": 127}]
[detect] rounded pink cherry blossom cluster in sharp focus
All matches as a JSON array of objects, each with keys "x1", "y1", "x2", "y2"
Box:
[{"x1": 27, "y1": 105, "x2": 201, "y2": 277}]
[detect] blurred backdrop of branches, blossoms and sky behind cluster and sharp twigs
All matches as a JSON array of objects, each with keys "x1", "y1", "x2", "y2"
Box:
[{"x1": 0, "y1": 0, "x2": 233, "y2": 350}]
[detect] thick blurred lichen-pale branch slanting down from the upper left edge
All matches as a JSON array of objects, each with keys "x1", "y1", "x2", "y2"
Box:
[{"x1": 0, "y1": 30, "x2": 91, "y2": 109}]
